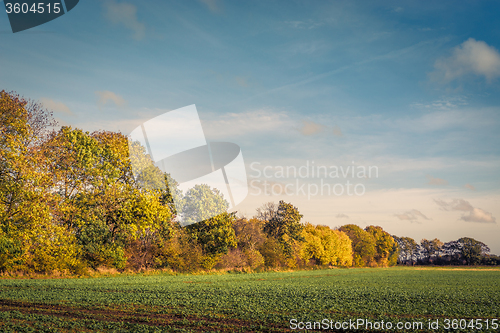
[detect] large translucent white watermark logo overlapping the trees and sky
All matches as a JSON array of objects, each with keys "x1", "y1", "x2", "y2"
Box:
[{"x1": 129, "y1": 104, "x2": 248, "y2": 226}]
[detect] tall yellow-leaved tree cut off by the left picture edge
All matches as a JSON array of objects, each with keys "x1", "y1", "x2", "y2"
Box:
[{"x1": 0, "y1": 91, "x2": 79, "y2": 272}]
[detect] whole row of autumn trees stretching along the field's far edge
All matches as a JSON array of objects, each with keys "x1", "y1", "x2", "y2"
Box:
[{"x1": 0, "y1": 91, "x2": 496, "y2": 274}]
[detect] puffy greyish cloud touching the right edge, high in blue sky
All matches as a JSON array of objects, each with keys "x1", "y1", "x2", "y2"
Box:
[{"x1": 431, "y1": 38, "x2": 500, "y2": 82}]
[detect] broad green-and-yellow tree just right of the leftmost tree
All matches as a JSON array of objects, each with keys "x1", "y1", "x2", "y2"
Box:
[{"x1": 44, "y1": 127, "x2": 173, "y2": 268}]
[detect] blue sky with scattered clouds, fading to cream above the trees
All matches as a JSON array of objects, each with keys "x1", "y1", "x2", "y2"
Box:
[{"x1": 0, "y1": 0, "x2": 500, "y2": 254}]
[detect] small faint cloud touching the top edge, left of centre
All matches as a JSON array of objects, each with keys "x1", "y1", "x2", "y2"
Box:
[{"x1": 103, "y1": 0, "x2": 146, "y2": 40}]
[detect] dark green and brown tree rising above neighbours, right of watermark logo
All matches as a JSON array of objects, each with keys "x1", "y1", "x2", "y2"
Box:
[{"x1": 264, "y1": 200, "x2": 304, "y2": 258}]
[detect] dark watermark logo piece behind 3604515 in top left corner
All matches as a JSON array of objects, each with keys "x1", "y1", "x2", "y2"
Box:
[{"x1": 3, "y1": 0, "x2": 79, "y2": 33}]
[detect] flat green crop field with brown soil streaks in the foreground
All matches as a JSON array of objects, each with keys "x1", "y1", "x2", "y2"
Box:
[{"x1": 0, "y1": 268, "x2": 500, "y2": 332}]
